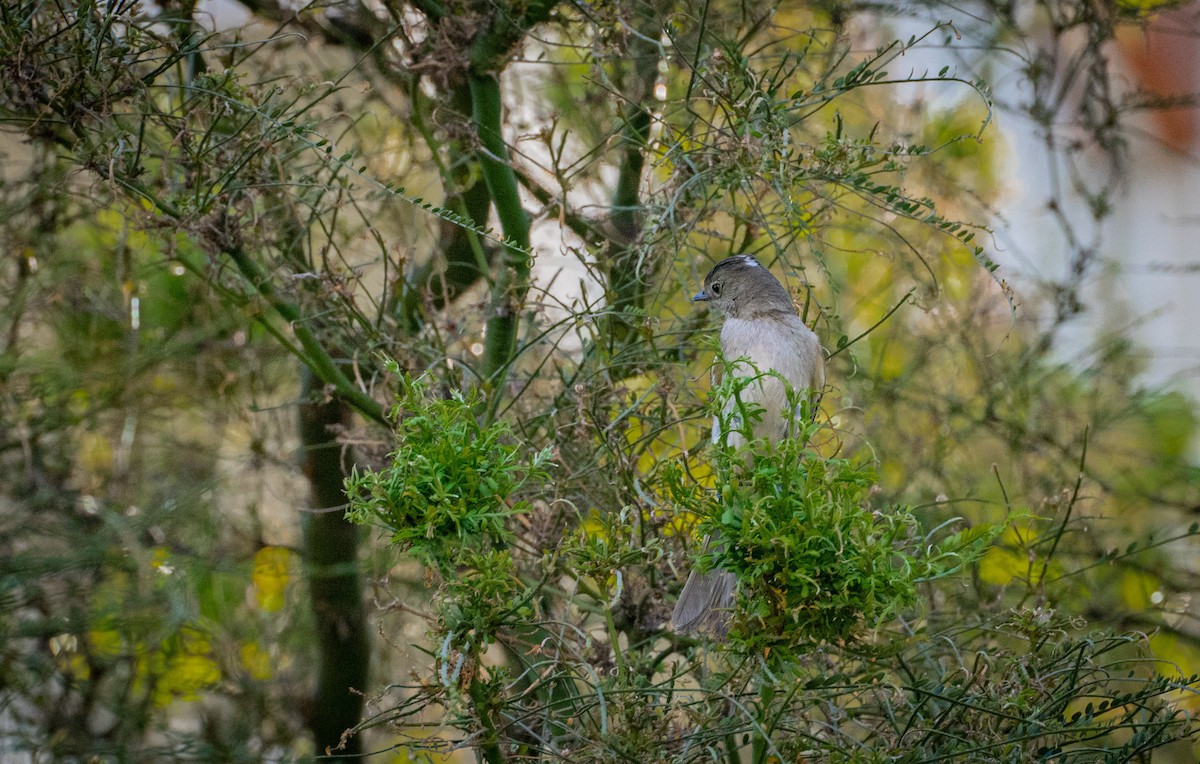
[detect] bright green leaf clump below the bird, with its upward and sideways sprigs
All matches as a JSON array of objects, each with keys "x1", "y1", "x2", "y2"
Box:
[{"x1": 664, "y1": 369, "x2": 1002, "y2": 651}]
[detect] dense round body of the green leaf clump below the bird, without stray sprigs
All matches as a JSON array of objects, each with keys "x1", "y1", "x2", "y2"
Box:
[{"x1": 701, "y1": 440, "x2": 917, "y2": 648}]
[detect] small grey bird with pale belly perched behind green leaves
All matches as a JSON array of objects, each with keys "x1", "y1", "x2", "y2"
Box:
[{"x1": 671, "y1": 254, "x2": 824, "y2": 636}]
